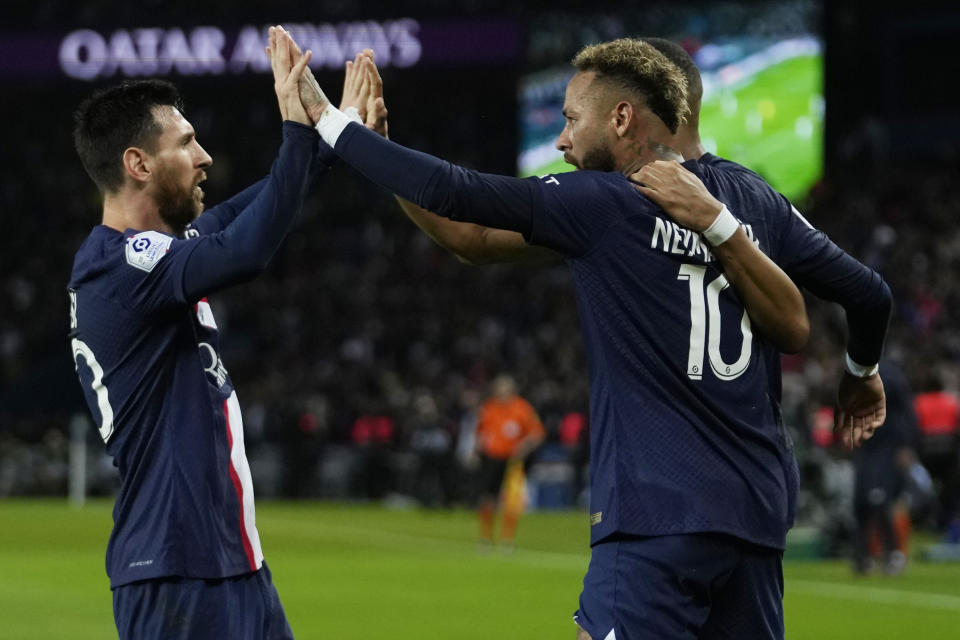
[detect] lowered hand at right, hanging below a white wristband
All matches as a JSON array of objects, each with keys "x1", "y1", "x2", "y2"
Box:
[{"x1": 833, "y1": 372, "x2": 887, "y2": 449}]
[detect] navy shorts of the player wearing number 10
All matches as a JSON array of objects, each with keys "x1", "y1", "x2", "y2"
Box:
[{"x1": 574, "y1": 534, "x2": 784, "y2": 640}]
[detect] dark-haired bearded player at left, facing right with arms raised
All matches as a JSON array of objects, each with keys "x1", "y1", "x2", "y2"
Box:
[{"x1": 69, "y1": 27, "x2": 364, "y2": 640}]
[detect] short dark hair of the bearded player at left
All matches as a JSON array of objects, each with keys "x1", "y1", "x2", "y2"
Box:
[{"x1": 73, "y1": 80, "x2": 184, "y2": 193}]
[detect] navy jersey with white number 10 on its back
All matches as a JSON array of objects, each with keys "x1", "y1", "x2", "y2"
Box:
[{"x1": 335, "y1": 125, "x2": 882, "y2": 548}]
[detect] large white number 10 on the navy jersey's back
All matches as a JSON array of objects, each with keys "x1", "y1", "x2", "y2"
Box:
[{"x1": 677, "y1": 264, "x2": 753, "y2": 381}]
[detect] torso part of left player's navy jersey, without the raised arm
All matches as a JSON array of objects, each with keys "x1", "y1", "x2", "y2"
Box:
[{"x1": 69, "y1": 226, "x2": 259, "y2": 587}]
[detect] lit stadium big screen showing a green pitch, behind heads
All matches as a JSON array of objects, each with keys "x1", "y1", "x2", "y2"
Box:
[{"x1": 517, "y1": 1, "x2": 824, "y2": 199}]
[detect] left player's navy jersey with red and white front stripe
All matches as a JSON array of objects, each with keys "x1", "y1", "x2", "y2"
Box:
[{"x1": 69, "y1": 123, "x2": 317, "y2": 587}]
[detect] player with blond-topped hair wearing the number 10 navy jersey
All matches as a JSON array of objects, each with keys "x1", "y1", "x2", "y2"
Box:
[{"x1": 286, "y1": 33, "x2": 889, "y2": 640}]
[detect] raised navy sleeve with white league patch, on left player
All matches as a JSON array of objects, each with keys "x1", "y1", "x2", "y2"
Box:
[{"x1": 121, "y1": 122, "x2": 317, "y2": 311}]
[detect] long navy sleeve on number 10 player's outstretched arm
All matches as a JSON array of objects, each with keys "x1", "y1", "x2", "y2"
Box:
[{"x1": 335, "y1": 124, "x2": 622, "y2": 256}]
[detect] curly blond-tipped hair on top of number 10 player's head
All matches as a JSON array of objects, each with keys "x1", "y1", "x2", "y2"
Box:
[{"x1": 573, "y1": 38, "x2": 690, "y2": 133}]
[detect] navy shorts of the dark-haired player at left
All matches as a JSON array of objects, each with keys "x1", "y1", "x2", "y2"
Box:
[{"x1": 113, "y1": 562, "x2": 293, "y2": 640}]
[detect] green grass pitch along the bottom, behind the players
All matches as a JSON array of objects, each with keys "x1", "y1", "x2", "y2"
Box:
[{"x1": 0, "y1": 500, "x2": 960, "y2": 640}]
